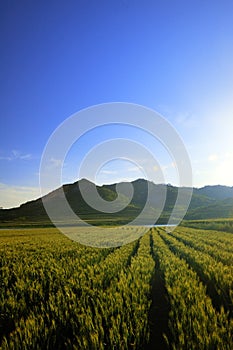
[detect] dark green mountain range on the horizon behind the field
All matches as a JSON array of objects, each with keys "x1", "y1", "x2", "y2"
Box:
[{"x1": 0, "y1": 179, "x2": 233, "y2": 225}]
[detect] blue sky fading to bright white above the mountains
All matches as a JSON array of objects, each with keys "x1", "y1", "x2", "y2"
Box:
[{"x1": 0, "y1": 0, "x2": 233, "y2": 208}]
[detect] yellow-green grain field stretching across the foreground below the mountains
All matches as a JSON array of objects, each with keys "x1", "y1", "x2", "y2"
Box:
[{"x1": 0, "y1": 227, "x2": 233, "y2": 350}]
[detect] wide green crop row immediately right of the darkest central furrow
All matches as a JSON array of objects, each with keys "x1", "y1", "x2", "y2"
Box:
[{"x1": 153, "y1": 230, "x2": 233, "y2": 350}]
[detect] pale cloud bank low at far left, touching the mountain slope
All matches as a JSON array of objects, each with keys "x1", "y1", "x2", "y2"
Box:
[{"x1": 0, "y1": 183, "x2": 41, "y2": 208}]
